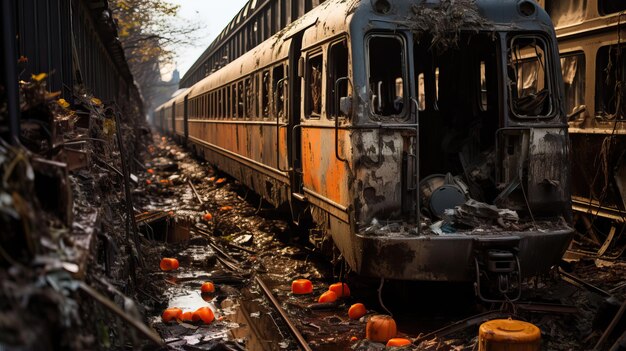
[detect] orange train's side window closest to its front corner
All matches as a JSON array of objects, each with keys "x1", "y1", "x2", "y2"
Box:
[{"x1": 326, "y1": 39, "x2": 350, "y2": 118}]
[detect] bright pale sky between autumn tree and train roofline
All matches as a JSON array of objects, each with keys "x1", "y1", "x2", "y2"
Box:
[{"x1": 162, "y1": 0, "x2": 248, "y2": 80}]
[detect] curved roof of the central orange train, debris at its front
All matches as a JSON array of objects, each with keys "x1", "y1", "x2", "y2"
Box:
[{"x1": 186, "y1": 0, "x2": 554, "y2": 97}]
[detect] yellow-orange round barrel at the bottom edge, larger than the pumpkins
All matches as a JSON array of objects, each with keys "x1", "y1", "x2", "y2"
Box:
[{"x1": 478, "y1": 318, "x2": 541, "y2": 351}]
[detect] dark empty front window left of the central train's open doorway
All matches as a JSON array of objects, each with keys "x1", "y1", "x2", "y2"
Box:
[{"x1": 367, "y1": 34, "x2": 407, "y2": 116}]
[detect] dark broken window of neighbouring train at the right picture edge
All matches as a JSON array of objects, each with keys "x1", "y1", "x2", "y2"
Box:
[{"x1": 596, "y1": 45, "x2": 626, "y2": 119}]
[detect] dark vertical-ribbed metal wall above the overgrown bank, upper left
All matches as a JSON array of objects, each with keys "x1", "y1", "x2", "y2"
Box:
[{"x1": 3, "y1": 0, "x2": 140, "y2": 105}]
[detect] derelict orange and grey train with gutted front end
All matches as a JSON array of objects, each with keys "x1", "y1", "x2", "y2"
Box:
[{"x1": 155, "y1": 0, "x2": 572, "y2": 296}]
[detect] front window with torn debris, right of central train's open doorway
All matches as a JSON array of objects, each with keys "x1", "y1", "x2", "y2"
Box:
[{"x1": 507, "y1": 36, "x2": 554, "y2": 118}]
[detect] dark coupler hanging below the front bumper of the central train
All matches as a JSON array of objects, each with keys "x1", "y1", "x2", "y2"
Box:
[{"x1": 474, "y1": 249, "x2": 522, "y2": 302}]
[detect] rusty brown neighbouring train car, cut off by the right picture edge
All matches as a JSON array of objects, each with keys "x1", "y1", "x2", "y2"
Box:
[{"x1": 541, "y1": 0, "x2": 626, "y2": 257}]
